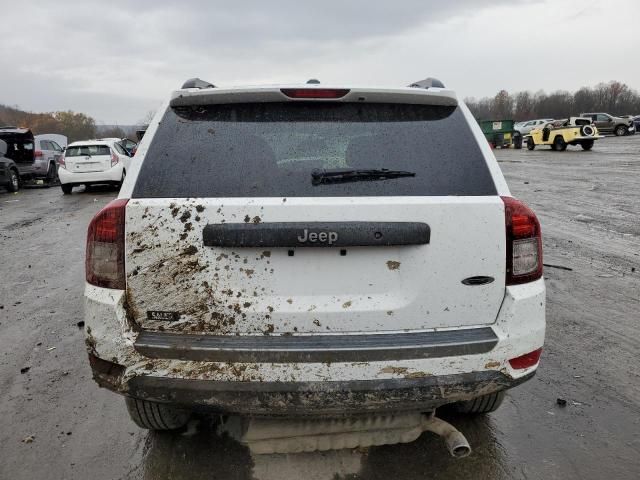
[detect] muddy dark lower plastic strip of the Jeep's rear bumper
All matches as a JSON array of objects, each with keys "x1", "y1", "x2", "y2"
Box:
[{"x1": 119, "y1": 371, "x2": 535, "y2": 416}]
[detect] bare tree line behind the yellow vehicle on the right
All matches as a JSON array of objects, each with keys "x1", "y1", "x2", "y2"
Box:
[{"x1": 465, "y1": 80, "x2": 640, "y2": 121}]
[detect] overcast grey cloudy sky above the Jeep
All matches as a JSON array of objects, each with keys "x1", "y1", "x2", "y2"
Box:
[{"x1": 0, "y1": 0, "x2": 640, "y2": 124}]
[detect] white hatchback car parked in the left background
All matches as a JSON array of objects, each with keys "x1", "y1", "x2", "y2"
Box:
[{"x1": 58, "y1": 140, "x2": 131, "y2": 194}]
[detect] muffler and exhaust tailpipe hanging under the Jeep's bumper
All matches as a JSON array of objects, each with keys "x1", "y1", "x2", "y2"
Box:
[{"x1": 219, "y1": 413, "x2": 471, "y2": 458}]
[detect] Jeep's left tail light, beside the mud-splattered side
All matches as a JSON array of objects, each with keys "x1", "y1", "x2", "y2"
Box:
[{"x1": 85, "y1": 199, "x2": 128, "y2": 290}]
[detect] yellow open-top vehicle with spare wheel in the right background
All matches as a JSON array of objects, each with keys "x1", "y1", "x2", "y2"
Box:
[{"x1": 525, "y1": 117, "x2": 603, "y2": 152}]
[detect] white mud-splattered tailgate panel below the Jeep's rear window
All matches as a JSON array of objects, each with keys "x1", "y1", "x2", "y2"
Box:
[{"x1": 125, "y1": 196, "x2": 505, "y2": 334}]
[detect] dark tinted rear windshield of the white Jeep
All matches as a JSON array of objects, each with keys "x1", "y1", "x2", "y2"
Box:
[{"x1": 133, "y1": 102, "x2": 496, "y2": 198}]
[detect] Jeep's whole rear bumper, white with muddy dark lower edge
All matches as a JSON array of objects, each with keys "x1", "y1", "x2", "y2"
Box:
[{"x1": 85, "y1": 280, "x2": 545, "y2": 415}]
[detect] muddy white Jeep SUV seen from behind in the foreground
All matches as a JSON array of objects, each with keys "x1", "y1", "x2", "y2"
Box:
[{"x1": 85, "y1": 79, "x2": 545, "y2": 438}]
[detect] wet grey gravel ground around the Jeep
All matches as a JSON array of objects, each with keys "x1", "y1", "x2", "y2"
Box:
[{"x1": 0, "y1": 135, "x2": 640, "y2": 480}]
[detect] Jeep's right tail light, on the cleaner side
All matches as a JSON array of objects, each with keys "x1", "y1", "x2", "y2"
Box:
[{"x1": 502, "y1": 197, "x2": 542, "y2": 285}]
